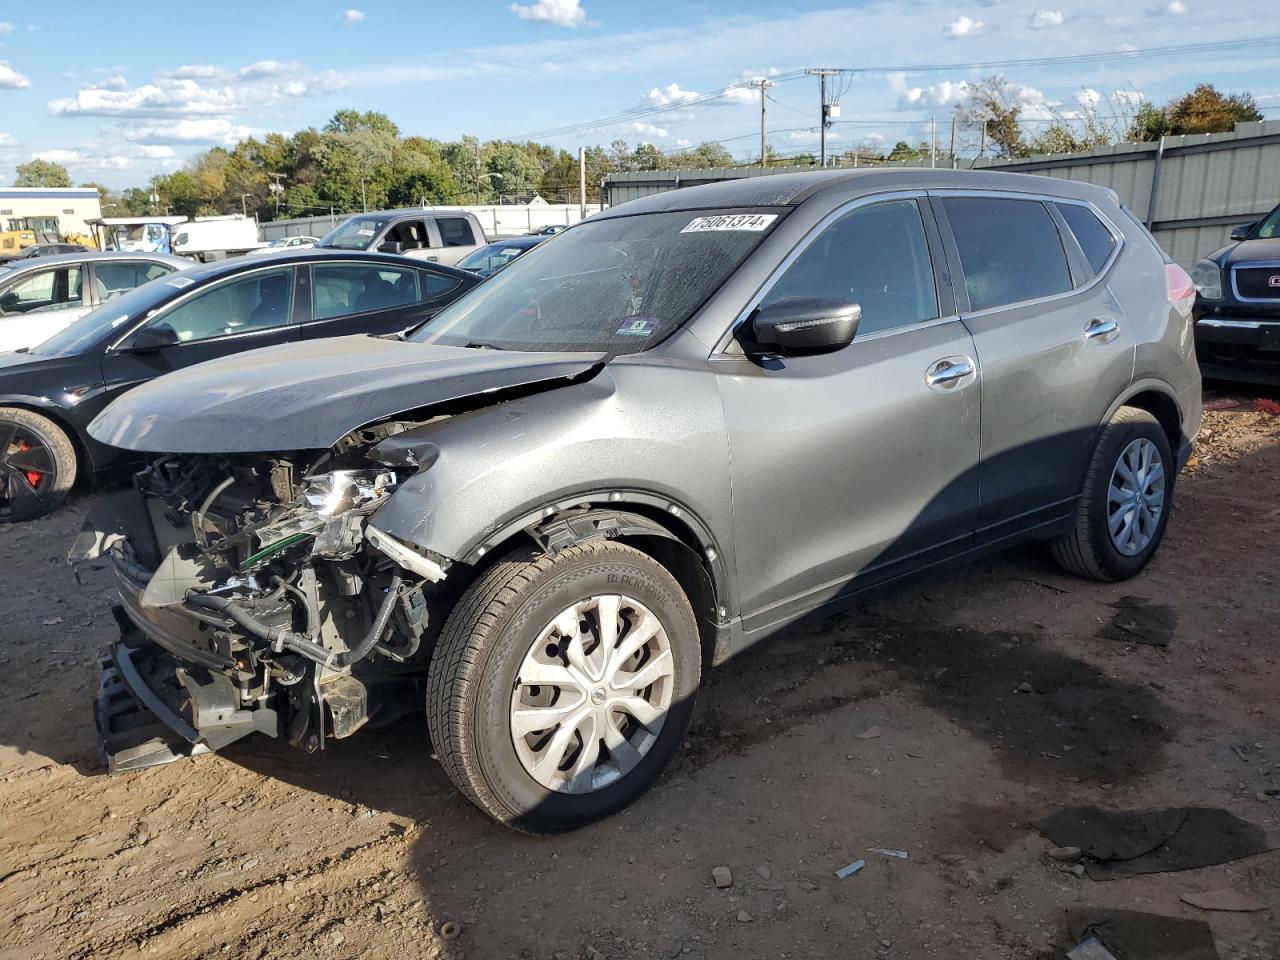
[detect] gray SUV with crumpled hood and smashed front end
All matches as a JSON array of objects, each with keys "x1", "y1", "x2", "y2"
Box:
[{"x1": 73, "y1": 170, "x2": 1201, "y2": 831}]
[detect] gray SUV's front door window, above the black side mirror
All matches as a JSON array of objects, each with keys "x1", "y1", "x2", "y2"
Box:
[{"x1": 762, "y1": 200, "x2": 938, "y2": 337}]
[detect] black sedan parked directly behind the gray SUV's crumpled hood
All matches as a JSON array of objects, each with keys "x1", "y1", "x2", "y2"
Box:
[{"x1": 0, "y1": 250, "x2": 480, "y2": 524}]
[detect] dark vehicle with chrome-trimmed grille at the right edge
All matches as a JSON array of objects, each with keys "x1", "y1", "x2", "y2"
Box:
[{"x1": 1192, "y1": 200, "x2": 1280, "y2": 384}]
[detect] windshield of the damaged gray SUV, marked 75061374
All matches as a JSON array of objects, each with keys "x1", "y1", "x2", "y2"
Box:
[{"x1": 412, "y1": 211, "x2": 777, "y2": 353}]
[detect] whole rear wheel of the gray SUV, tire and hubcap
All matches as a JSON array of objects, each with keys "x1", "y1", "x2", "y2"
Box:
[{"x1": 1053, "y1": 407, "x2": 1176, "y2": 581}]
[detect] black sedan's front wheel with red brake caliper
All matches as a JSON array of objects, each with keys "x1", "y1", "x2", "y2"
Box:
[{"x1": 0, "y1": 407, "x2": 76, "y2": 524}]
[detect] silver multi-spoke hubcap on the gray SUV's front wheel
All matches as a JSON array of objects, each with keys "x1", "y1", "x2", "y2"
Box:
[{"x1": 511, "y1": 594, "x2": 675, "y2": 794}]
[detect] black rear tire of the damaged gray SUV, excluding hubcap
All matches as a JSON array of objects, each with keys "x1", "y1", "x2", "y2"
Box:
[{"x1": 1051, "y1": 407, "x2": 1178, "y2": 582}]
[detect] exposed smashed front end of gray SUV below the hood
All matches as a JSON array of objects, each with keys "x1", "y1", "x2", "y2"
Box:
[{"x1": 70, "y1": 440, "x2": 448, "y2": 772}]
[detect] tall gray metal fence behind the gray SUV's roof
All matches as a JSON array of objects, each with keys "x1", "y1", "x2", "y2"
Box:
[{"x1": 605, "y1": 120, "x2": 1280, "y2": 268}]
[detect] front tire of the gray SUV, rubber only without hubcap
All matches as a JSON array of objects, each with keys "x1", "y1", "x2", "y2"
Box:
[{"x1": 426, "y1": 541, "x2": 701, "y2": 833}]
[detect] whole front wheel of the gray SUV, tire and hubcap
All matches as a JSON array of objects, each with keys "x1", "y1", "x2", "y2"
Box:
[{"x1": 426, "y1": 541, "x2": 701, "y2": 832}]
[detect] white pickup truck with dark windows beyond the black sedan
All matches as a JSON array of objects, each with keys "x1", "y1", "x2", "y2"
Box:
[{"x1": 316, "y1": 210, "x2": 489, "y2": 266}]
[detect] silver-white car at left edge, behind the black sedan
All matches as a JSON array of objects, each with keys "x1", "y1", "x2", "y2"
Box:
[{"x1": 0, "y1": 253, "x2": 191, "y2": 353}]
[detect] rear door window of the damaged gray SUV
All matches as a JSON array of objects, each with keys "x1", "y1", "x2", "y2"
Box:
[{"x1": 942, "y1": 197, "x2": 1071, "y2": 311}]
